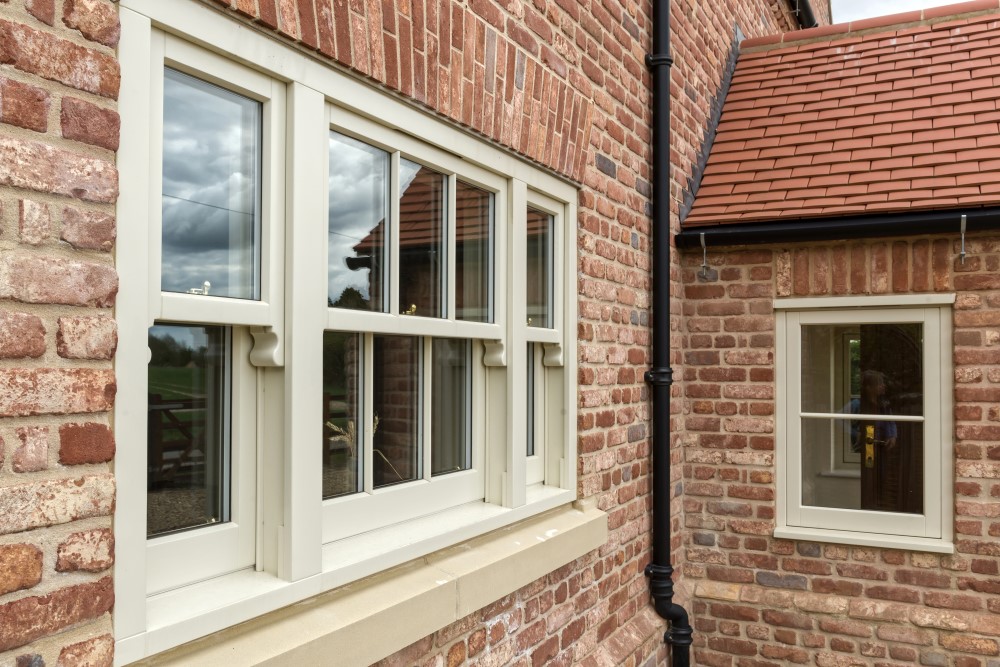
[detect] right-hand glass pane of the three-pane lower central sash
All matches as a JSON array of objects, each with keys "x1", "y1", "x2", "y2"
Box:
[{"x1": 431, "y1": 338, "x2": 472, "y2": 475}]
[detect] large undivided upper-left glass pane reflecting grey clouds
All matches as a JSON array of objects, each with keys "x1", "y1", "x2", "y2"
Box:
[{"x1": 160, "y1": 69, "x2": 262, "y2": 299}]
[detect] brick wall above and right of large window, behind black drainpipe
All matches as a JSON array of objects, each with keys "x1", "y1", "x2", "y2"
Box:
[{"x1": 199, "y1": 0, "x2": 797, "y2": 667}]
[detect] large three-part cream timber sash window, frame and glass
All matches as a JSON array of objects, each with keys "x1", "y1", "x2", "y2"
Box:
[{"x1": 115, "y1": 0, "x2": 588, "y2": 664}]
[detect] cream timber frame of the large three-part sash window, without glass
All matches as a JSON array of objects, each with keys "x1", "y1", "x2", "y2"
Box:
[{"x1": 114, "y1": 0, "x2": 584, "y2": 664}]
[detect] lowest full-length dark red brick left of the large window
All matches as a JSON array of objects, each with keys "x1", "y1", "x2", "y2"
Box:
[{"x1": 0, "y1": 577, "x2": 114, "y2": 651}]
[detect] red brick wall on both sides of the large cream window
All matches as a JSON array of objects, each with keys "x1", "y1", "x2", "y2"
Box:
[{"x1": 0, "y1": 0, "x2": 816, "y2": 665}]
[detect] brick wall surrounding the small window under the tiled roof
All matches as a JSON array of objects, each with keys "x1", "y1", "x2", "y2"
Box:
[{"x1": 681, "y1": 236, "x2": 1000, "y2": 667}]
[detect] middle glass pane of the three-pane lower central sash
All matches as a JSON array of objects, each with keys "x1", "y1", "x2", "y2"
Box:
[{"x1": 372, "y1": 336, "x2": 422, "y2": 488}]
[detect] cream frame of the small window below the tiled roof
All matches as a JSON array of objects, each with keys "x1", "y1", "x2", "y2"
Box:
[{"x1": 774, "y1": 295, "x2": 954, "y2": 553}]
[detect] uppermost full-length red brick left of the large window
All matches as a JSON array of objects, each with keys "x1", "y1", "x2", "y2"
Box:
[{"x1": 0, "y1": 20, "x2": 121, "y2": 97}]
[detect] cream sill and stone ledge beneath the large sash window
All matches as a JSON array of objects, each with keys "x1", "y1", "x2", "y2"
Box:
[{"x1": 115, "y1": 494, "x2": 607, "y2": 667}]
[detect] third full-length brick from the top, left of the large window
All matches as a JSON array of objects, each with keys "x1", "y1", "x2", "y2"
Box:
[{"x1": 0, "y1": 255, "x2": 118, "y2": 308}]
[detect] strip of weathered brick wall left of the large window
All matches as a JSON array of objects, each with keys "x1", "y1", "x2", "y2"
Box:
[{"x1": 0, "y1": 0, "x2": 119, "y2": 665}]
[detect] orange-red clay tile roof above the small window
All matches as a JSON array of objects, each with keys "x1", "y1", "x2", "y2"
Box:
[{"x1": 683, "y1": 0, "x2": 1000, "y2": 228}]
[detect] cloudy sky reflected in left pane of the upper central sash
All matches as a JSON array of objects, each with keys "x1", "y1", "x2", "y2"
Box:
[{"x1": 327, "y1": 132, "x2": 389, "y2": 301}]
